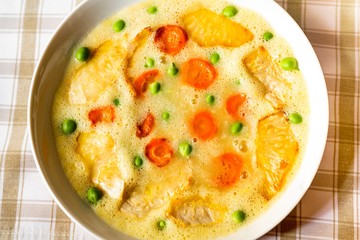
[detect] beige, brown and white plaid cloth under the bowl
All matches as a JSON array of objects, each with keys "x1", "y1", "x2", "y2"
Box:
[{"x1": 0, "y1": 0, "x2": 360, "y2": 239}]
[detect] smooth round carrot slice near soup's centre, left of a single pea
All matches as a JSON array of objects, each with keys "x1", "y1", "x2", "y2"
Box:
[{"x1": 190, "y1": 111, "x2": 218, "y2": 140}]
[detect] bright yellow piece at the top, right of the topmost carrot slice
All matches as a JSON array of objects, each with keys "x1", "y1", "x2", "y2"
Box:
[{"x1": 183, "y1": 9, "x2": 254, "y2": 47}]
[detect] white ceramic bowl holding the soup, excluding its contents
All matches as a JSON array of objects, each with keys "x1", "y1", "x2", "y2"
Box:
[{"x1": 28, "y1": 0, "x2": 328, "y2": 239}]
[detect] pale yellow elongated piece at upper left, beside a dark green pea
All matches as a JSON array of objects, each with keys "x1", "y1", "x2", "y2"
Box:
[{"x1": 69, "y1": 40, "x2": 126, "y2": 104}]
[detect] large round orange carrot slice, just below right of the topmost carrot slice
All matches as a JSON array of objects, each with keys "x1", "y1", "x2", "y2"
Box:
[{"x1": 181, "y1": 58, "x2": 217, "y2": 90}]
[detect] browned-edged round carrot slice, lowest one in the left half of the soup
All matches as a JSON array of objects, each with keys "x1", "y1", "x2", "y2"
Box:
[{"x1": 145, "y1": 138, "x2": 173, "y2": 167}]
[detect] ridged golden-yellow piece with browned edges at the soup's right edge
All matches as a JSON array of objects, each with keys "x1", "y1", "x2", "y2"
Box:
[{"x1": 256, "y1": 112, "x2": 299, "y2": 199}]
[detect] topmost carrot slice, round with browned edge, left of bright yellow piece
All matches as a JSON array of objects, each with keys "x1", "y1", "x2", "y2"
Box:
[{"x1": 155, "y1": 25, "x2": 188, "y2": 55}]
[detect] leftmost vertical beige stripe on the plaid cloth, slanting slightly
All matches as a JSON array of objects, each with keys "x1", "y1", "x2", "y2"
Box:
[{"x1": 0, "y1": 0, "x2": 39, "y2": 236}]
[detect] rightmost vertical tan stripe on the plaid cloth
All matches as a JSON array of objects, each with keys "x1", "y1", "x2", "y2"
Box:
[{"x1": 336, "y1": 0, "x2": 359, "y2": 239}]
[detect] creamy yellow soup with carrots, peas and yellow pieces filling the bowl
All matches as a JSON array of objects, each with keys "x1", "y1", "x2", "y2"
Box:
[{"x1": 52, "y1": 0, "x2": 309, "y2": 239}]
